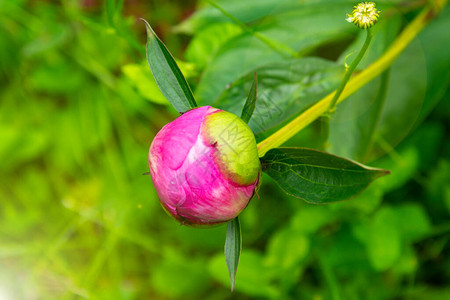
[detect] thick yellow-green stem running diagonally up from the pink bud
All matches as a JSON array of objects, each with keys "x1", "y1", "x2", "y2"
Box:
[{"x1": 258, "y1": 5, "x2": 440, "y2": 157}]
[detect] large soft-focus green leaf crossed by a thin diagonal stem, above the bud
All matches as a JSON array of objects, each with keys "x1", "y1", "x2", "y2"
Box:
[{"x1": 195, "y1": 2, "x2": 357, "y2": 105}]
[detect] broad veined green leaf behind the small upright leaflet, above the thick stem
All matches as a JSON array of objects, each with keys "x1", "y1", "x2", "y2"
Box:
[{"x1": 213, "y1": 57, "x2": 344, "y2": 138}]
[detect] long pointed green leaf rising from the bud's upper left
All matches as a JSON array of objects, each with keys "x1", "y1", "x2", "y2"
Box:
[{"x1": 142, "y1": 19, "x2": 197, "y2": 113}]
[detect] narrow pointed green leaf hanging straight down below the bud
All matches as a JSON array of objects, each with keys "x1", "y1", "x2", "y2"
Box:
[{"x1": 225, "y1": 217, "x2": 242, "y2": 291}]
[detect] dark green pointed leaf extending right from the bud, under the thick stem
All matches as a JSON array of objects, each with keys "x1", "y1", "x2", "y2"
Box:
[{"x1": 261, "y1": 148, "x2": 389, "y2": 204}]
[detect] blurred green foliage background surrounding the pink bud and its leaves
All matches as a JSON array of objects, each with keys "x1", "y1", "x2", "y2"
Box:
[{"x1": 0, "y1": 0, "x2": 450, "y2": 300}]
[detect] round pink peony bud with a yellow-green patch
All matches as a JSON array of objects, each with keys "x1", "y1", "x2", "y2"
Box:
[{"x1": 149, "y1": 106, "x2": 261, "y2": 225}]
